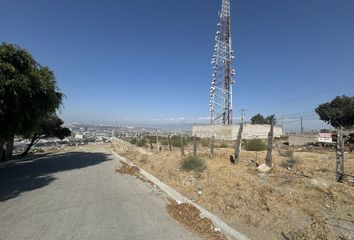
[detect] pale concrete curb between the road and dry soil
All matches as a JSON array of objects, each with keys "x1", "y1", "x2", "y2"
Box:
[{"x1": 111, "y1": 150, "x2": 249, "y2": 240}]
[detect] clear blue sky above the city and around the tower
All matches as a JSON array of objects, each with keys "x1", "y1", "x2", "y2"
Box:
[{"x1": 0, "y1": 0, "x2": 354, "y2": 129}]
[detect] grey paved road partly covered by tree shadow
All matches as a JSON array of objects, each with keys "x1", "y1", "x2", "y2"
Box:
[{"x1": 0, "y1": 145, "x2": 198, "y2": 240}]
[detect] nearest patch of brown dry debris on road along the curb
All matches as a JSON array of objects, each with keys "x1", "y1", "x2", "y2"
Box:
[{"x1": 167, "y1": 201, "x2": 227, "y2": 240}]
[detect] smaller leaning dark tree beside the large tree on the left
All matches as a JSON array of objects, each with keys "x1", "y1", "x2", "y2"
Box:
[{"x1": 22, "y1": 114, "x2": 71, "y2": 156}]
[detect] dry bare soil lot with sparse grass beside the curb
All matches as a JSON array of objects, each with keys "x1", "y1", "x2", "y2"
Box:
[{"x1": 112, "y1": 141, "x2": 354, "y2": 239}]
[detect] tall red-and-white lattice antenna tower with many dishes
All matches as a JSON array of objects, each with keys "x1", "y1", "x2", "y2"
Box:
[{"x1": 209, "y1": 0, "x2": 235, "y2": 125}]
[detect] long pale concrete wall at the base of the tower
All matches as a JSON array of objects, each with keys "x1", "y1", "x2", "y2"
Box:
[{"x1": 192, "y1": 124, "x2": 283, "y2": 140}]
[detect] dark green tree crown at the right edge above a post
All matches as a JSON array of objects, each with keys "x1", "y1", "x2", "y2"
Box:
[{"x1": 315, "y1": 95, "x2": 354, "y2": 129}]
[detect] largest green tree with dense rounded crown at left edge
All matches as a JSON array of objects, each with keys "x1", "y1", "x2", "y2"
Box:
[{"x1": 0, "y1": 43, "x2": 63, "y2": 160}]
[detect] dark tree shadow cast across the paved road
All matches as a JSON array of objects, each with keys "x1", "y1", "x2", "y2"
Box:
[{"x1": 0, "y1": 152, "x2": 111, "y2": 202}]
